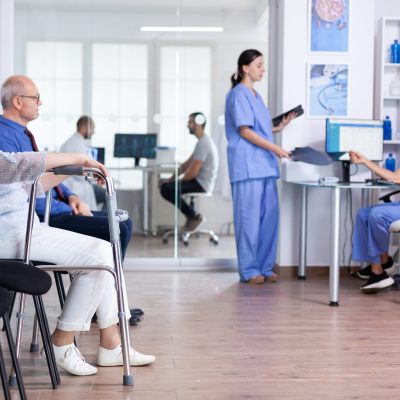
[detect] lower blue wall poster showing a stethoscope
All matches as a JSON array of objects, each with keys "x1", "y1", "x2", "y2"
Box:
[{"x1": 307, "y1": 64, "x2": 348, "y2": 118}]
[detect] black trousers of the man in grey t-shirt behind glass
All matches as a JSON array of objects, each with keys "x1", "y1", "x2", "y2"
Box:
[{"x1": 160, "y1": 179, "x2": 205, "y2": 218}]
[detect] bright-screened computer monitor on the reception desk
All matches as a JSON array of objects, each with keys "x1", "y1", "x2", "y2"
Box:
[{"x1": 325, "y1": 118, "x2": 383, "y2": 182}]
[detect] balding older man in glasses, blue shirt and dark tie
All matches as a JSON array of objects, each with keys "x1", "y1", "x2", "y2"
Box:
[{"x1": 0, "y1": 75, "x2": 143, "y2": 325}]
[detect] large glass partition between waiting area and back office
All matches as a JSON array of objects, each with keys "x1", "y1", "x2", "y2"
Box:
[{"x1": 15, "y1": 0, "x2": 269, "y2": 260}]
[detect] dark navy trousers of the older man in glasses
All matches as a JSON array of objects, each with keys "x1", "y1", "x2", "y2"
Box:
[{"x1": 41, "y1": 211, "x2": 132, "y2": 258}]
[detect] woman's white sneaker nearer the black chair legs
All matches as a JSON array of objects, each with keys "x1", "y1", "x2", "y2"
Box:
[{"x1": 48, "y1": 343, "x2": 97, "y2": 376}]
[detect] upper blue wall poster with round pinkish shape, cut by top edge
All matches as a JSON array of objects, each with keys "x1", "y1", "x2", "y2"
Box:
[{"x1": 309, "y1": 0, "x2": 350, "y2": 53}]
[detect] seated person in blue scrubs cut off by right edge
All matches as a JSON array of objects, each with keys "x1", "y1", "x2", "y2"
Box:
[{"x1": 350, "y1": 151, "x2": 400, "y2": 293}]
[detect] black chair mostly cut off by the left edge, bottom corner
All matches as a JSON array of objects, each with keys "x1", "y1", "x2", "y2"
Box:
[{"x1": 0, "y1": 287, "x2": 26, "y2": 400}]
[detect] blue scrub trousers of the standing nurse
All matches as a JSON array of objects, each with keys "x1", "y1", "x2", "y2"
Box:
[{"x1": 231, "y1": 178, "x2": 279, "y2": 282}]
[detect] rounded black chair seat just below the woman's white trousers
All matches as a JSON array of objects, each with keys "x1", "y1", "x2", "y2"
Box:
[{"x1": 0, "y1": 260, "x2": 51, "y2": 295}]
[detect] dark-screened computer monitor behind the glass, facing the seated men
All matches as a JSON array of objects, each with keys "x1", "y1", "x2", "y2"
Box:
[{"x1": 114, "y1": 133, "x2": 157, "y2": 166}]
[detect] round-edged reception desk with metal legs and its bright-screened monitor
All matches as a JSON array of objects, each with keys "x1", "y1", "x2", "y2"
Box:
[{"x1": 289, "y1": 118, "x2": 396, "y2": 306}]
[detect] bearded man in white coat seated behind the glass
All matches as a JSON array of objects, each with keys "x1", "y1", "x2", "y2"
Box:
[{"x1": 60, "y1": 115, "x2": 105, "y2": 210}]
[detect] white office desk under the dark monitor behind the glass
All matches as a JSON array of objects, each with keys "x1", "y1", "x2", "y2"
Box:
[{"x1": 107, "y1": 164, "x2": 176, "y2": 235}]
